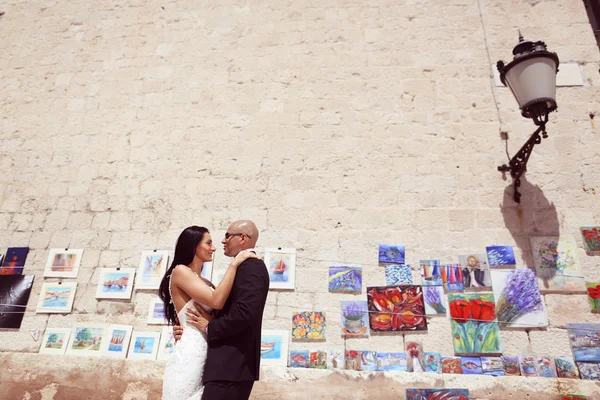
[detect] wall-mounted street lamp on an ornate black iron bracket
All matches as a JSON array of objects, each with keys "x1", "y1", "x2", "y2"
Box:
[{"x1": 496, "y1": 32, "x2": 559, "y2": 203}]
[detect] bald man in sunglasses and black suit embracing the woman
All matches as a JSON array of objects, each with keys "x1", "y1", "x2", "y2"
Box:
[{"x1": 180, "y1": 220, "x2": 269, "y2": 400}]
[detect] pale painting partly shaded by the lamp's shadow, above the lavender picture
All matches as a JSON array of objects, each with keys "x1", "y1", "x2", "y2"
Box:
[{"x1": 529, "y1": 236, "x2": 585, "y2": 293}]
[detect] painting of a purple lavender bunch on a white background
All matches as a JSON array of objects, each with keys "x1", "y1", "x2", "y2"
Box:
[{"x1": 491, "y1": 268, "x2": 548, "y2": 329}]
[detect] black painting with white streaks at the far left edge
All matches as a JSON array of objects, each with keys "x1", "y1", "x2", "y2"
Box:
[{"x1": 0, "y1": 275, "x2": 35, "y2": 329}]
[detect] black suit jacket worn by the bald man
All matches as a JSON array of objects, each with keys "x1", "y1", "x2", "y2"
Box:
[{"x1": 202, "y1": 258, "x2": 269, "y2": 382}]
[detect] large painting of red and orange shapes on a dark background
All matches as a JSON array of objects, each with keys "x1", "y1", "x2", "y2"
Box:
[{"x1": 367, "y1": 285, "x2": 427, "y2": 332}]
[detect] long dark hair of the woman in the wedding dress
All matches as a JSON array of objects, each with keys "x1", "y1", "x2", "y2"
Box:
[{"x1": 158, "y1": 225, "x2": 215, "y2": 325}]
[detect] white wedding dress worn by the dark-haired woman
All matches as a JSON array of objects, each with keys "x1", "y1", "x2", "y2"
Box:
[{"x1": 163, "y1": 300, "x2": 212, "y2": 400}]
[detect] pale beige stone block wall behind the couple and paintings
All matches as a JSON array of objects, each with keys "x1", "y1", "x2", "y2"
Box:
[{"x1": 0, "y1": 0, "x2": 600, "y2": 399}]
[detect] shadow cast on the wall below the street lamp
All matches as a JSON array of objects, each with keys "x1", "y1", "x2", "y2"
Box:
[{"x1": 500, "y1": 176, "x2": 561, "y2": 270}]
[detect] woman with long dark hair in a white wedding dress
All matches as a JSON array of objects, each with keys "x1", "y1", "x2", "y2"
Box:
[{"x1": 159, "y1": 226, "x2": 256, "y2": 400}]
